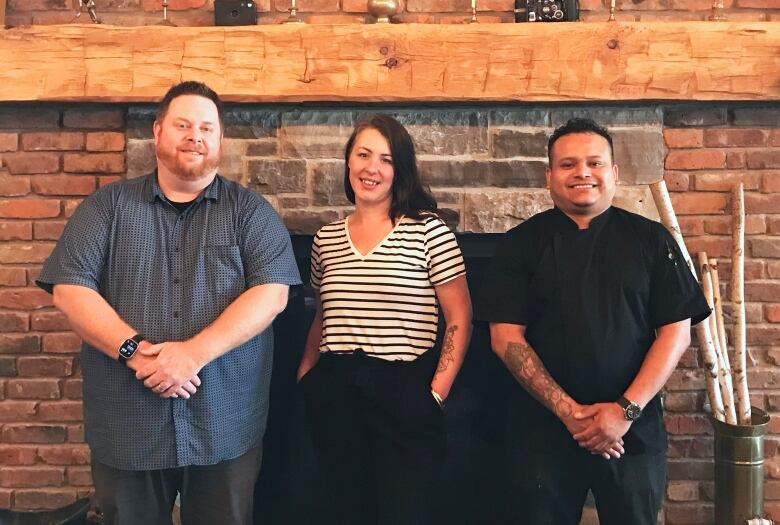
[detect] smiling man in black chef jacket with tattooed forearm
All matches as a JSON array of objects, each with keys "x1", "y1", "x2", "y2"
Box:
[{"x1": 475, "y1": 119, "x2": 709, "y2": 525}]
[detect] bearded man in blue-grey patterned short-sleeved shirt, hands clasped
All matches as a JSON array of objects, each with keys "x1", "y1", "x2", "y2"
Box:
[{"x1": 37, "y1": 82, "x2": 300, "y2": 525}]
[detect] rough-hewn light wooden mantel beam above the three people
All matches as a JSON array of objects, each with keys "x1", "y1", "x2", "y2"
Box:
[{"x1": 0, "y1": 22, "x2": 780, "y2": 102}]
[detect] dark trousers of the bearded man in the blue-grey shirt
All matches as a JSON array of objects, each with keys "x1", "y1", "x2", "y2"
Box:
[{"x1": 92, "y1": 448, "x2": 262, "y2": 525}]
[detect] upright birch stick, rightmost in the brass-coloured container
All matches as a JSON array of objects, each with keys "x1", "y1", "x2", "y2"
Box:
[{"x1": 731, "y1": 183, "x2": 751, "y2": 425}]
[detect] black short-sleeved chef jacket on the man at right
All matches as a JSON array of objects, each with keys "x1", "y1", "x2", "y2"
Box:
[{"x1": 475, "y1": 206, "x2": 710, "y2": 453}]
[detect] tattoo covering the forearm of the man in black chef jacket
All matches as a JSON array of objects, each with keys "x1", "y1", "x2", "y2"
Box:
[{"x1": 504, "y1": 342, "x2": 572, "y2": 417}]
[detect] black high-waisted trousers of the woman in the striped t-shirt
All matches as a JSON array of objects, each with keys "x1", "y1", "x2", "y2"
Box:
[{"x1": 300, "y1": 351, "x2": 445, "y2": 525}]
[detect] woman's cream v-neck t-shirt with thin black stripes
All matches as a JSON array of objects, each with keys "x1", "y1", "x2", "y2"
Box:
[{"x1": 311, "y1": 214, "x2": 466, "y2": 361}]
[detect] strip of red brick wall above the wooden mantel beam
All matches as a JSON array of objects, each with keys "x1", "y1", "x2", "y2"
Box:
[{"x1": 6, "y1": 0, "x2": 780, "y2": 26}]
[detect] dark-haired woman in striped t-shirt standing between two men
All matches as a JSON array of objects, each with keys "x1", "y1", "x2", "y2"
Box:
[{"x1": 298, "y1": 115, "x2": 471, "y2": 525}]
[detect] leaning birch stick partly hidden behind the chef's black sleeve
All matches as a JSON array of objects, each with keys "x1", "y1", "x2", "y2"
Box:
[{"x1": 650, "y1": 179, "x2": 726, "y2": 421}]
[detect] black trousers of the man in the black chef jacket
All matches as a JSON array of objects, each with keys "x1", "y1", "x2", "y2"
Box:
[{"x1": 504, "y1": 437, "x2": 666, "y2": 525}]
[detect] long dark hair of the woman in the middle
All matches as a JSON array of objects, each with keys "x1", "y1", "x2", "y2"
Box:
[{"x1": 344, "y1": 113, "x2": 436, "y2": 221}]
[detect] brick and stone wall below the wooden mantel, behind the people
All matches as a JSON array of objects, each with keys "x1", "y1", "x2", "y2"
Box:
[{"x1": 0, "y1": 103, "x2": 780, "y2": 524}]
